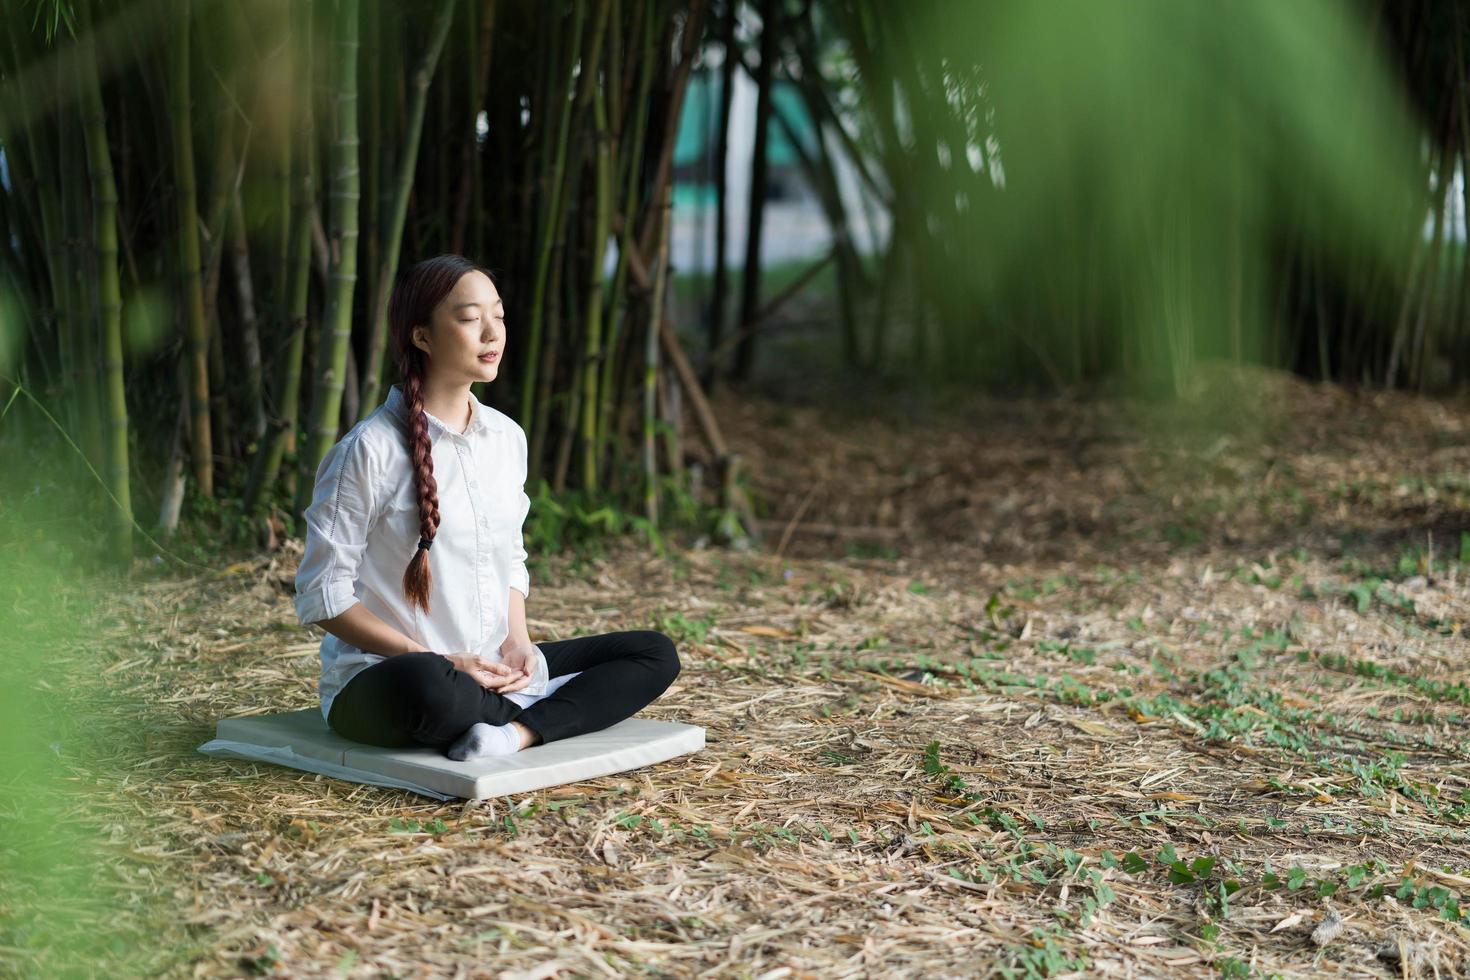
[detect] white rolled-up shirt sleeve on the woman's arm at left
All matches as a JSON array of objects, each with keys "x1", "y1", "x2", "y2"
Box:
[{"x1": 295, "y1": 433, "x2": 373, "y2": 626}]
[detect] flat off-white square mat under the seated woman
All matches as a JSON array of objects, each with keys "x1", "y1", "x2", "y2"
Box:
[{"x1": 198, "y1": 708, "x2": 704, "y2": 799}]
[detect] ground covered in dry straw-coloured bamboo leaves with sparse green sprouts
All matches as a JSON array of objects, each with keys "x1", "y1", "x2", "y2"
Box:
[{"x1": 0, "y1": 364, "x2": 1470, "y2": 980}]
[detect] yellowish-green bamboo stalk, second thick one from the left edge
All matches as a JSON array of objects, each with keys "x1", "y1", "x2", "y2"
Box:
[{"x1": 169, "y1": 0, "x2": 215, "y2": 497}]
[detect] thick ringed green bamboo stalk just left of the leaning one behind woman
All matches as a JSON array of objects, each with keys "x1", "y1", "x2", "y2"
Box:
[{"x1": 295, "y1": 0, "x2": 360, "y2": 514}]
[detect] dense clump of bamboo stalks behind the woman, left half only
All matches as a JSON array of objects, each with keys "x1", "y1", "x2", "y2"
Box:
[{"x1": 0, "y1": 0, "x2": 704, "y2": 567}]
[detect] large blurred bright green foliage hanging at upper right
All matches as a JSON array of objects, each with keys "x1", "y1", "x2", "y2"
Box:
[{"x1": 823, "y1": 0, "x2": 1429, "y2": 391}]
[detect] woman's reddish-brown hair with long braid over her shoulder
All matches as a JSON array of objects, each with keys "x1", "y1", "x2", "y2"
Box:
[{"x1": 388, "y1": 254, "x2": 494, "y2": 613}]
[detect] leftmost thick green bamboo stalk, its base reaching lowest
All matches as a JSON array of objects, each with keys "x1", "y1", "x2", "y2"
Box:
[{"x1": 78, "y1": 21, "x2": 132, "y2": 567}]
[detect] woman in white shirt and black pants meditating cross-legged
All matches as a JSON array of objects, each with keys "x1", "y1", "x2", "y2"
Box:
[{"x1": 295, "y1": 256, "x2": 679, "y2": 760}]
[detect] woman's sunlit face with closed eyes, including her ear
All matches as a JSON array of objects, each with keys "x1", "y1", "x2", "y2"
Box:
[{"x1": 413, "y1": 270, "x2": 506, "y2": 385}]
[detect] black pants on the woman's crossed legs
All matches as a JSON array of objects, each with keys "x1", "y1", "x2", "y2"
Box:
[{"x1": 326, "y1": 630, "x2": 679, "y2": 748}]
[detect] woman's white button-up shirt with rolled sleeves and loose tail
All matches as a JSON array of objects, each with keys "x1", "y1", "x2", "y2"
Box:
[{"x1": 295, "y1": 385, "x2": 531, "y2": 718}]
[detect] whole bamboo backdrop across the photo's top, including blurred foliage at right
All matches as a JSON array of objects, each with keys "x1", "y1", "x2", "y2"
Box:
[{"x1": 0, "y1": 0, "x2": 1470, "y2": 575}]
